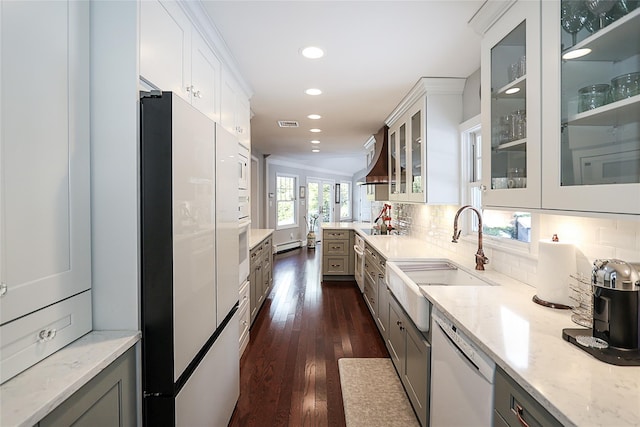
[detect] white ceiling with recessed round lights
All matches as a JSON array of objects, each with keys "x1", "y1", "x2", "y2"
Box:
[{"x1": 203, "y1": 0, "x2": 484, "y2": 174}]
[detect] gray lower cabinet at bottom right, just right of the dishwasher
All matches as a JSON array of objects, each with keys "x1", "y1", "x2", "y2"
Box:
[{"x1": 493, "y1": 367, "x2": 562, "y2": 427}]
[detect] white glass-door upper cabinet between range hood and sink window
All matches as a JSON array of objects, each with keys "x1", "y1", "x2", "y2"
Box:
[{"x1": 385, "y1": 77, "x2": 465, "y2": 204}]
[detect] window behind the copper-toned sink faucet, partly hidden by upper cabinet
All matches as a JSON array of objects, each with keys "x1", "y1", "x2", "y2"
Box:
[{"x1": 461, "y1": 117, "x2": 531, "y2": 243}]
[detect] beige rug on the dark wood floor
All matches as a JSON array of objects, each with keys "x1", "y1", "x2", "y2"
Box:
[{"x1": 338, "y1": 358, "x2": 419, "y2": 427}]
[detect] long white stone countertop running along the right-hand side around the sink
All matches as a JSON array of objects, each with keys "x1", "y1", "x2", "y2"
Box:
[{"x1": 323, "y1": 223, "x2": 640, "y2": 427}]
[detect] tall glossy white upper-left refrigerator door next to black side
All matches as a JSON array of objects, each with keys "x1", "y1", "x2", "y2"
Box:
[{"x1": 172, "y1": 97, "x2": 218, "y2": 379}]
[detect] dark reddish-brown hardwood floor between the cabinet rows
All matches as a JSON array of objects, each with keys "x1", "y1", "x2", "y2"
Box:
[{"x1": 229, "y1": 242, "x2": 389, "y2": 427}]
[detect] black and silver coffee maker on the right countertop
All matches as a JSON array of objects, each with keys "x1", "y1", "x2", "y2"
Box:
[{"x1": 591, "y1": 259, "x2": 640, "y2": 351}]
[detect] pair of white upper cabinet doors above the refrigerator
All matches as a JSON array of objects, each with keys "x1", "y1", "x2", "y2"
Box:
[{"x1": 140, "y1": 0, "x2": 221, "y2": 121}]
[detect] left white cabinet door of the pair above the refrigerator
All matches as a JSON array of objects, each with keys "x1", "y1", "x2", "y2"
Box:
[{"x1": 140, "y1": 0, "x2": 191, "y2": 102}]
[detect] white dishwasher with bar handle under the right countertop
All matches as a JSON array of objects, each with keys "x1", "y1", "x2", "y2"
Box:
[{"x1": 430, "y1": 308, "x2": 495, "y2": 427}]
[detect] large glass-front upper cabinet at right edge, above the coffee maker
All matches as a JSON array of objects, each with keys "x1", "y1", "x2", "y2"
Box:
[{"x1": 542, "y1": 0, "x2": 640, "y2": 214}]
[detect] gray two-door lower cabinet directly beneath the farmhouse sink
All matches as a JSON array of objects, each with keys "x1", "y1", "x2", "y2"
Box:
[{"x1": 387, "y1": 294, "x2": 431, "y2": 426}]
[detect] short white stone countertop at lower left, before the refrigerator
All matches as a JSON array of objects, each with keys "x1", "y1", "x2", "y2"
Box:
[{"x1": 0, "y1": 331, "x2": 140, "y2": 427}]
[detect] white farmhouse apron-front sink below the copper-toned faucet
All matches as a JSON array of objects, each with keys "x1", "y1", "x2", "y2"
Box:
[{"x1": 385, "y1": 261, "x2": 489, "y2": 332}]
